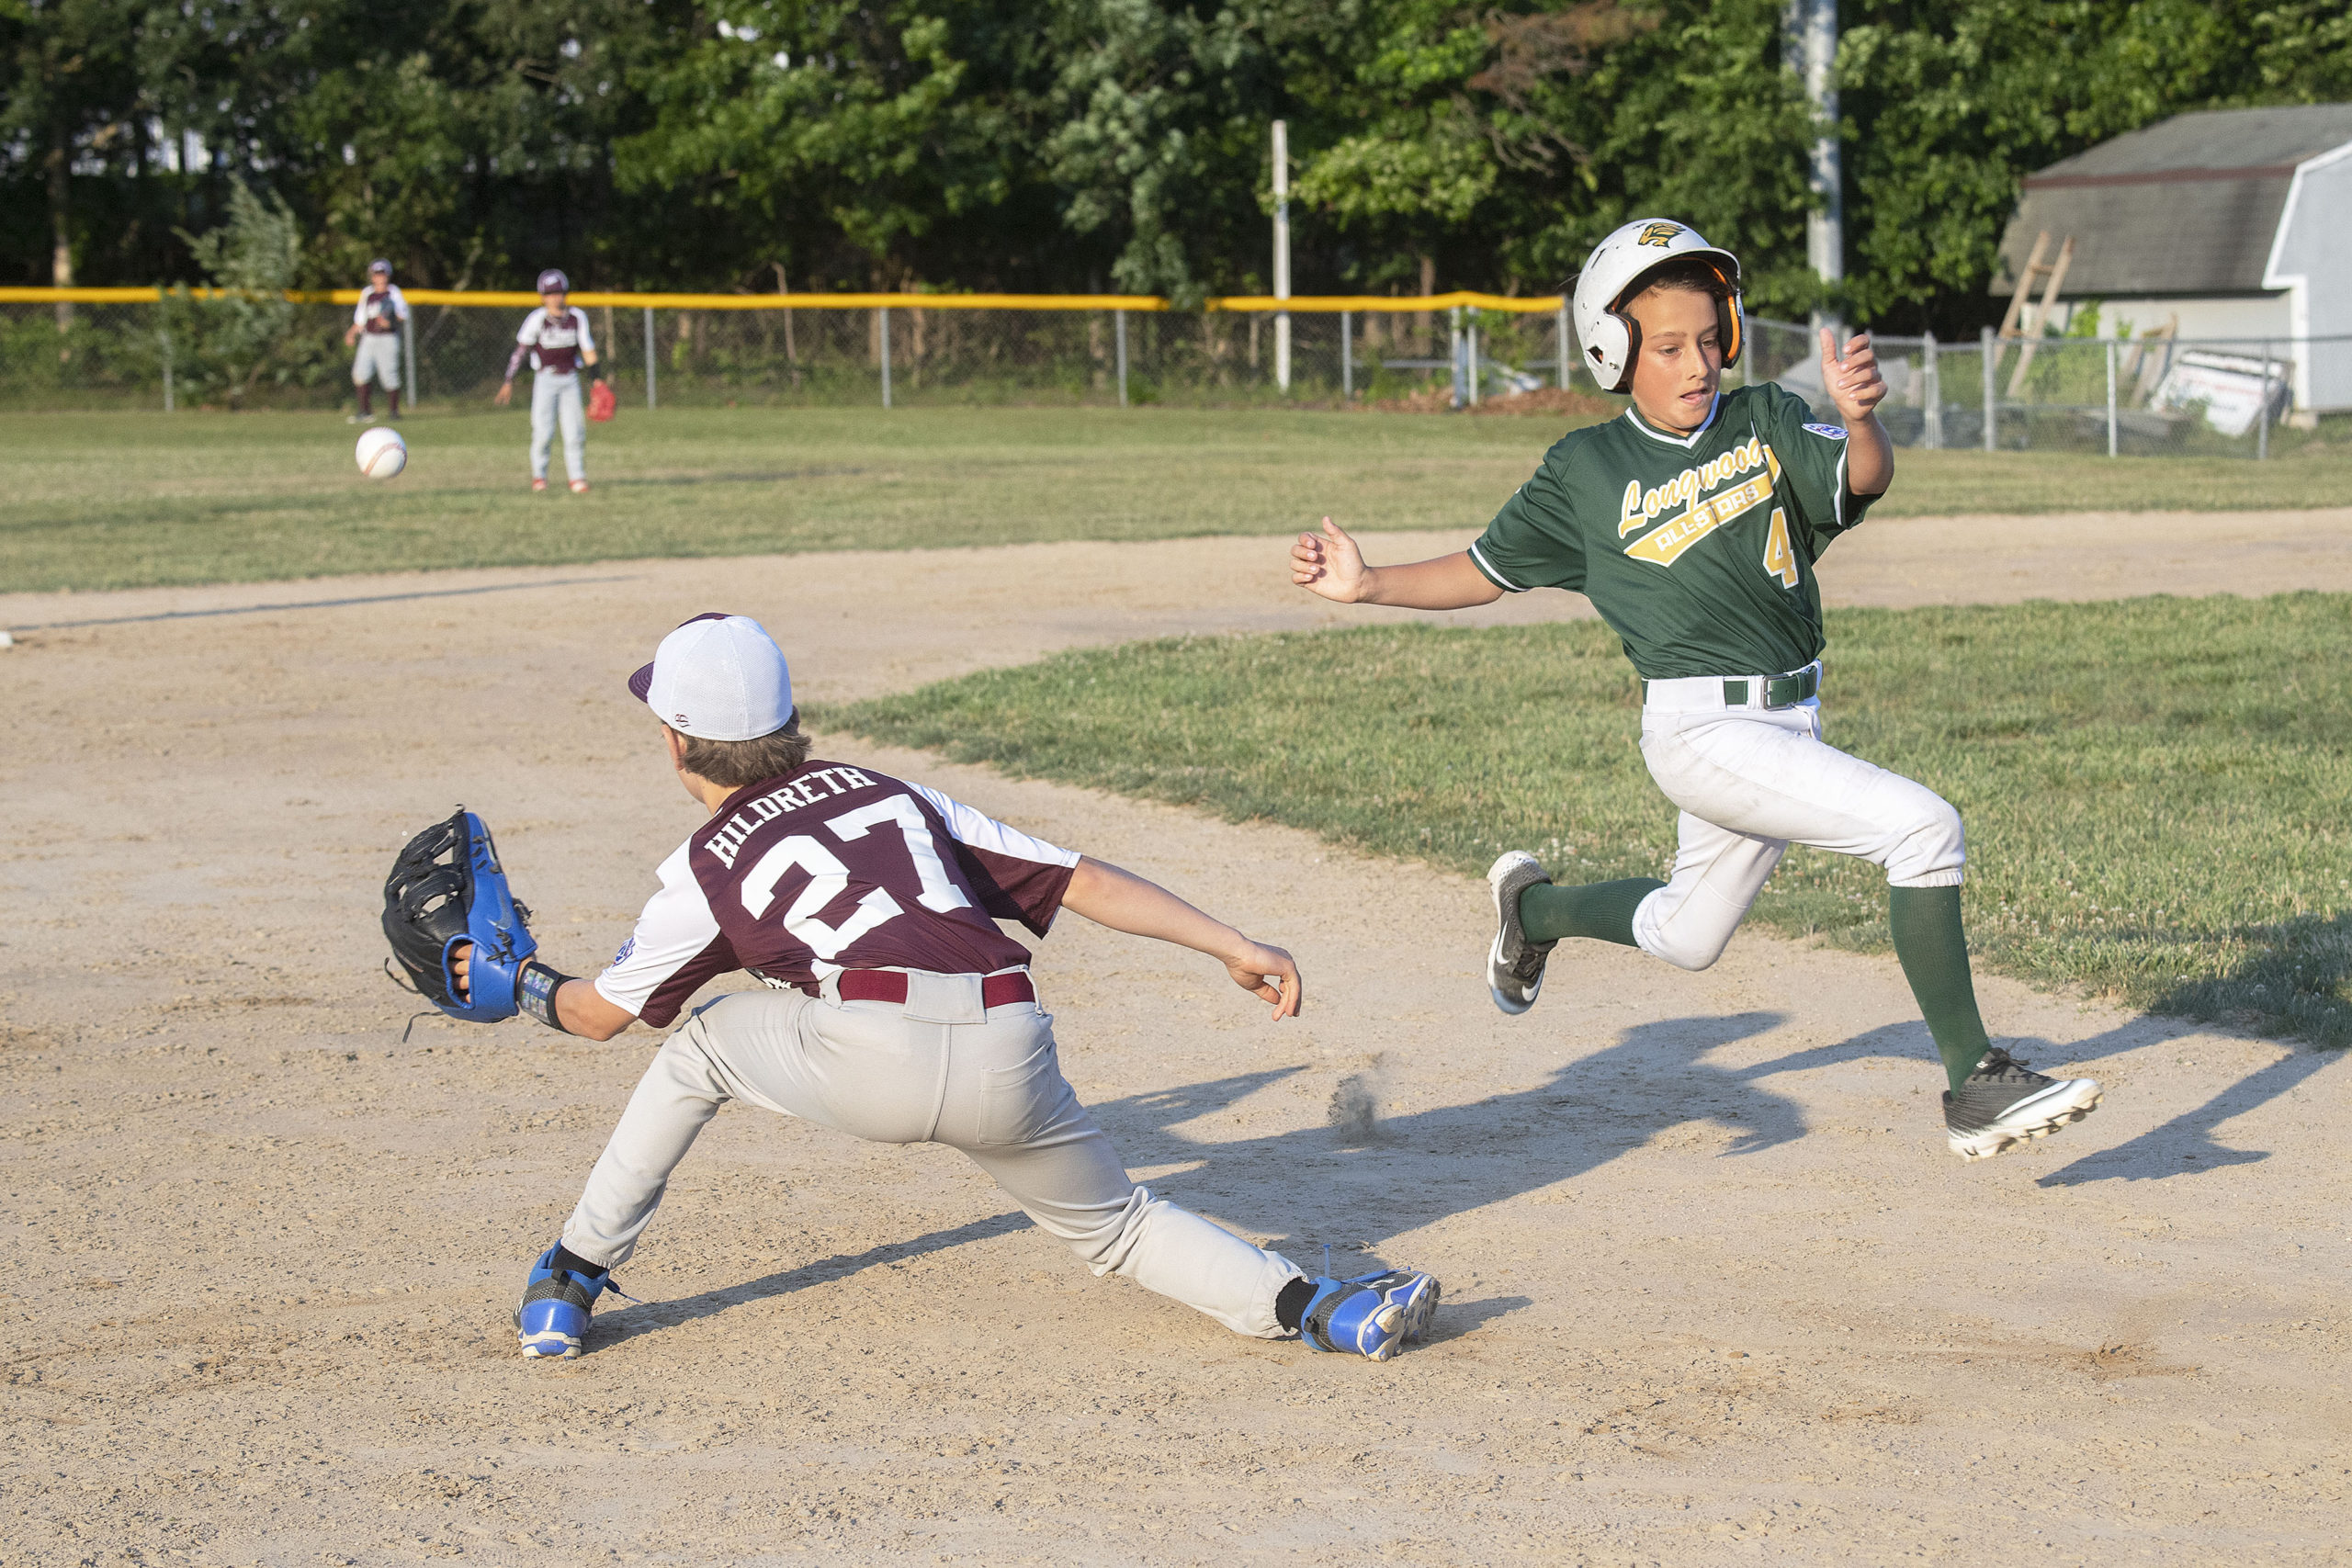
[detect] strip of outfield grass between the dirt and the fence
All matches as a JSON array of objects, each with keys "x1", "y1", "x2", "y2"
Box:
[{"x1": 14, "y1": 409, "x2": 2352, "y2": 590}]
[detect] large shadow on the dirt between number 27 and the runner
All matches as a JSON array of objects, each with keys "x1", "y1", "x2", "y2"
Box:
[{"x1": 1093, "y1": 1013, "x2": 1804, "y2": 1269}]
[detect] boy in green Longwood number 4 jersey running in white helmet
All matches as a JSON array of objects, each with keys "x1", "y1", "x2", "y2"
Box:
[{"x1": 1291, "y1": 219, "x2": 2100, "y2": 1159}]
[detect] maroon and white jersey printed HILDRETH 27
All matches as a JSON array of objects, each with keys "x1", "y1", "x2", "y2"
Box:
[{"x1": 595, "y1": 760, "x2": 1077, "y2": 1030}]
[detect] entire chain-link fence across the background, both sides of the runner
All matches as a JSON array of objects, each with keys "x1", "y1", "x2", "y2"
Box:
[{"x1": 0, "y1": 294, "x2": 2352, "y2": 458}]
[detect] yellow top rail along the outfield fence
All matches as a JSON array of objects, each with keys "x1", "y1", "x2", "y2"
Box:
[{"x1": 14, "y1": 287, "x2": 1566, "y2": 315}]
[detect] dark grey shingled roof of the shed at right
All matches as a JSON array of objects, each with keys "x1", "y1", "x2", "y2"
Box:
[{"x1": 1992, "y1": 104, "x2": 2352, "y2": 299}]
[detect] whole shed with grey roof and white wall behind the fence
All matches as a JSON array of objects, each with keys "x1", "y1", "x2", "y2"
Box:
[{"x1": 1995, "y1": 104, "x2": 2352, "y2": 413}]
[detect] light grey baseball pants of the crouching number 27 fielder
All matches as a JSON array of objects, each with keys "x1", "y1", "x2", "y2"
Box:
[{"x1": 564, "y1": 974, "x2": 1301, "y2": 1340}]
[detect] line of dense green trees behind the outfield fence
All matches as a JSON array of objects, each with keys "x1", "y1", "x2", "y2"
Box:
[{"x1": 0, "y1": 0, "x2": 2352, "y2": 332}]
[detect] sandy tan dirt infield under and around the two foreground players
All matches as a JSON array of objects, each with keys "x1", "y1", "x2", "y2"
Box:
[{"x1": 0, "y1": 513, "x2": 2352, "y2": 1563}]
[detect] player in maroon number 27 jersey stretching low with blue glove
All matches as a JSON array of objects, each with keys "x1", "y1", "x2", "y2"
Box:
[{"x1": 412, "y1": 614, "x2": 1440, "y2": 1361}]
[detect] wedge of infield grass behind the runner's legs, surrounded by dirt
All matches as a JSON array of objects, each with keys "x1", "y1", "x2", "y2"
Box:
[{"x1": 819, "y1": 592, "x2": 2352, "y2": 1043}]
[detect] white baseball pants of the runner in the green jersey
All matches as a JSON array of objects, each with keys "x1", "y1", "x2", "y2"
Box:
[{"x1": 1633, "y1": 677, "x2": 1969, "y2": 968}]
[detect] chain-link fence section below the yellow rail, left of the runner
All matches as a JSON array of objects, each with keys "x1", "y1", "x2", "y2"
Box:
[{"x1": 0, "y1": 296, "x2": 1557, "y2": 409}]
